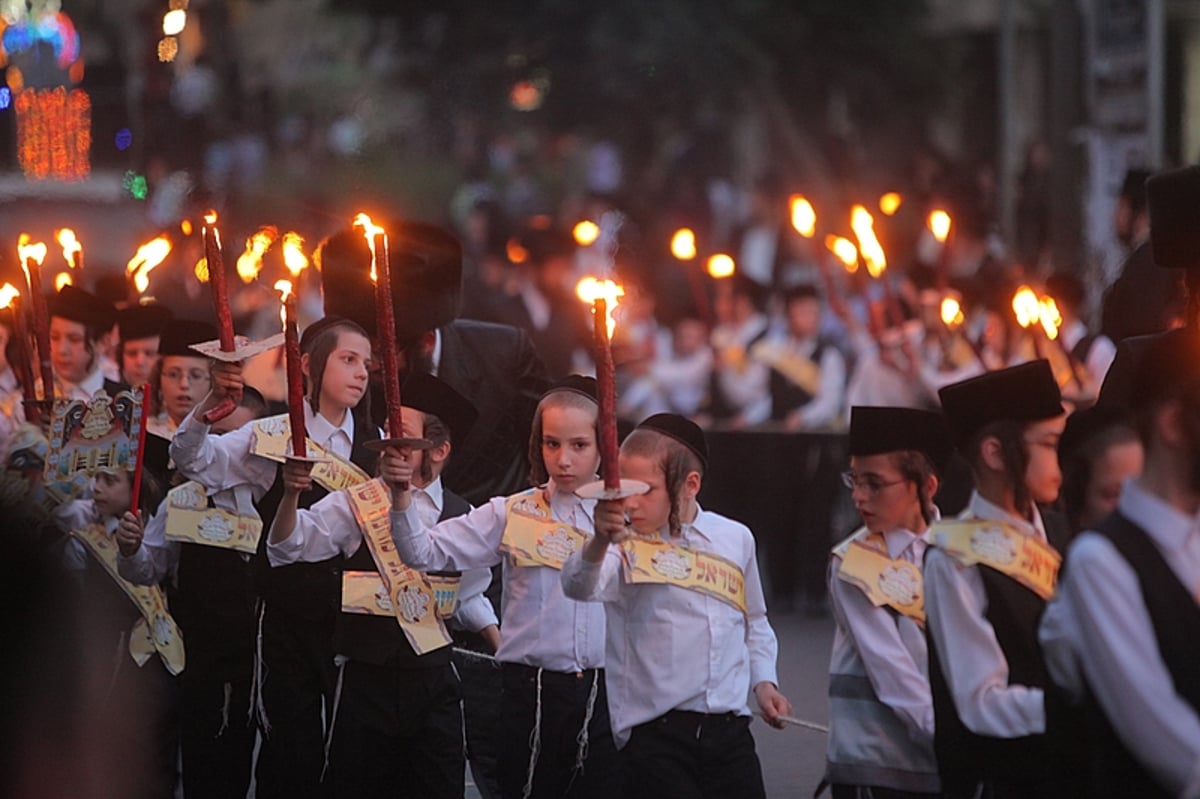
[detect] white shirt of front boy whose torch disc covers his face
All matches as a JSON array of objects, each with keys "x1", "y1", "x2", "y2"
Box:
[{"x1": 562, "y1": 510, "x2": 779, "y2": 747}]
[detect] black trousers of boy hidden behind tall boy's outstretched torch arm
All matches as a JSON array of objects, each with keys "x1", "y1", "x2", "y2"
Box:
[{"x1": 179, "y1": 631, "x2": 257, "y2": 799}]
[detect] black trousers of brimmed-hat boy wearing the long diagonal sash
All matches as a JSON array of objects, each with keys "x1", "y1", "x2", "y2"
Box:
[{"x1": 328, "y1": 660, "x2": 464, "y2": 799}]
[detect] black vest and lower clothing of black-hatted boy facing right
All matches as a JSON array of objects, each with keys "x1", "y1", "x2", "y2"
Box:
[{"x1": 925, "y1": 512, "x2": 1084, "y2": 787}]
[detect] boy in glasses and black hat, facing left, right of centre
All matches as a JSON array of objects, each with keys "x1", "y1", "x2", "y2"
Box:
[{"x1": 824, "y1": 407, "x2": 953, "y2": 799}]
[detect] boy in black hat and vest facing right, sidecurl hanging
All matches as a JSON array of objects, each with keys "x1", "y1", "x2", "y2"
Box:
[{"x1": 925, "y1": 360, "x2": 1080, "y2": 798}]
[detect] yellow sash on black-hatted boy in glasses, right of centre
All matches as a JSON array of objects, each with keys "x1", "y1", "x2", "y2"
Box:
[{"x1": 834, "y1": 530, "x2": 925, "y2": 626}]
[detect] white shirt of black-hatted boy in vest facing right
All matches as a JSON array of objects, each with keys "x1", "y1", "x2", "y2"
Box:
[{"x1": 925, "y1": 492, "x2": 1046, "y2": 738}]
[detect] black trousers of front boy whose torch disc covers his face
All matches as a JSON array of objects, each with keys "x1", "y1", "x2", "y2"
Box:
[{"x1": 620, "y1": 710, "x2": 767, "y2": 799}]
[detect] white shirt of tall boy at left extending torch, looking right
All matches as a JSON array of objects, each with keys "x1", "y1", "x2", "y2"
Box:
[{"x1": 170, "y1": 397, "x2": 354, "y2": 491}]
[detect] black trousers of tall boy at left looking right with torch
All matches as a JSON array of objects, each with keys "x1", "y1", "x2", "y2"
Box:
[{"x1": 254, "y1": 602, "x2": 337, "y2": 799}]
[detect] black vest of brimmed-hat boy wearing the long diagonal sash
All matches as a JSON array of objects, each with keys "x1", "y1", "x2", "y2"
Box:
[{"x1": 334, "y1": 491, "x2": 470, "y2": 668}]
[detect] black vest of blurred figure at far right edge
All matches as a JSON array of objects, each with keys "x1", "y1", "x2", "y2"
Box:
[{"x1": 1085, "y1": 512, "x2": 1200, "y2": 798}]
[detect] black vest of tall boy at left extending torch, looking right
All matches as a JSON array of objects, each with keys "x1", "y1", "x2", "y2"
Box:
[{"x1": 254, "y1": 408, "x2": 379, "y2": 630}]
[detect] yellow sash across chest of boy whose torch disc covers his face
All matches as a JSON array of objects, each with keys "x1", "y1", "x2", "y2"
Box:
[{"x1": 620, "y1": 539, "x2": 746, "y2": 613}]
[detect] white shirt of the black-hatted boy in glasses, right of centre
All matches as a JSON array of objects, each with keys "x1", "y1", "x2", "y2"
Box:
[{"x1": 829, "y1": 529, "x2": 934, "y2": 746}]
